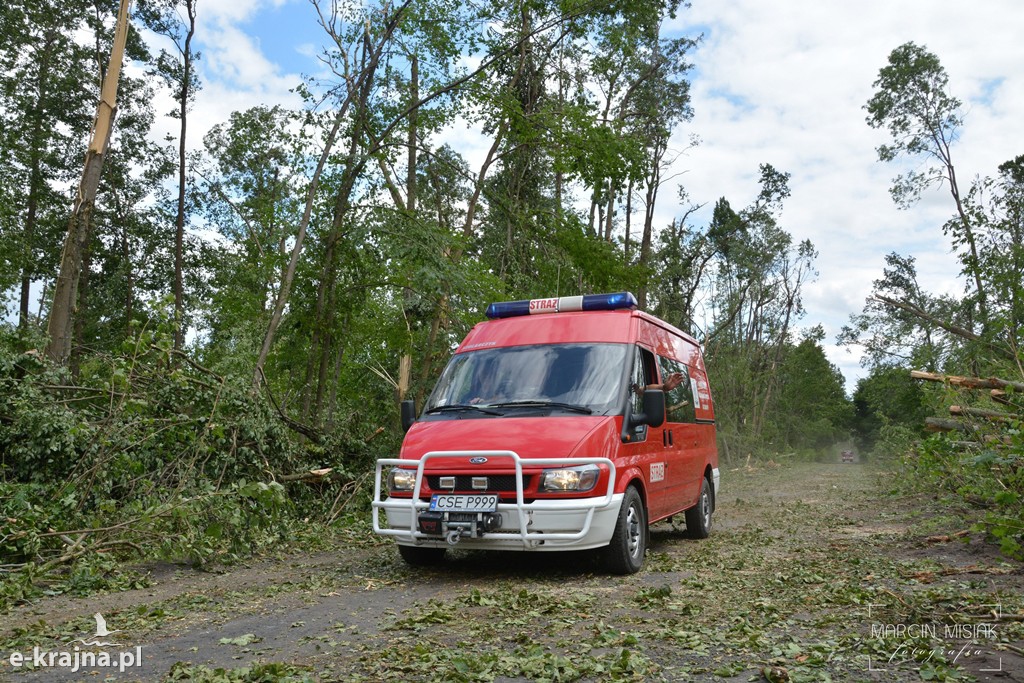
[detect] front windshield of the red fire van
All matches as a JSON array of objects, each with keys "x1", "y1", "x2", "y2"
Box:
[{"x1": 425, "y1": 344, "x2": 629, "y2": 416}]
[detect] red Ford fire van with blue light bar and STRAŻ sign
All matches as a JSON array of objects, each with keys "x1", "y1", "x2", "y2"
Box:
[{"x1": 373, "y1": 292, "x2": 719, "y2": 573}]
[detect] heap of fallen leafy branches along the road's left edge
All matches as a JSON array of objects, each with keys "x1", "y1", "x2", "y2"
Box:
[{"x1": 0, "y1": 315, "x2": 366, "y2": 604}]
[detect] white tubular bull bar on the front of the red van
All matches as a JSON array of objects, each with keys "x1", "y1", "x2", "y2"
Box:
[{"x1": 372, "y1": 451, "x2": 615, "y2": 548}]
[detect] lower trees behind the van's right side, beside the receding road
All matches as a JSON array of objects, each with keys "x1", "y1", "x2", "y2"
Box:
[{"x1": 650, "y1": 164, "x2": 852, "y2": 462}]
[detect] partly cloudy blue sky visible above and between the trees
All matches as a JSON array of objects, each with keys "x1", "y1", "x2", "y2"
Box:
[{"x1": 146, "y1": 0, "x2": 1024, "y2": 391}]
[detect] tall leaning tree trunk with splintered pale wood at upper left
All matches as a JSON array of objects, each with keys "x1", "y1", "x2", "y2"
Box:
[{"x1": 46, "y1": 0, "x2": 131, "y2": 365}]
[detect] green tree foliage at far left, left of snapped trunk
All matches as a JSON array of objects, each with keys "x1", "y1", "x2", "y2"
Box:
[{"x1": 0, "y1": 0, "x2": 98, "y2": 324}]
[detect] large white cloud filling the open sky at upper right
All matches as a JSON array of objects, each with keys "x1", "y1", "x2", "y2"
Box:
[{"x1": 663, "y1": 0, "x2": 1024, "y2": 389}]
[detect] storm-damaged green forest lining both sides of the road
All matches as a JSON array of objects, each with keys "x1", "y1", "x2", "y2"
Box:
[{"x1": 0, "y1": 0, "x2": 1024, "y2": 605}]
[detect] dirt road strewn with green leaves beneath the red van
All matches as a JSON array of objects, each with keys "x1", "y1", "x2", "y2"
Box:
[{"x1": 0, "y1": 464, "x2": 1024, "y2": 681}]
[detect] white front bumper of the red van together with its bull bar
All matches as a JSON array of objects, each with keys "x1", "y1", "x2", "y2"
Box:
[{"x1": 373, "y1": 451, "x2": 623, "y2": 551}]
